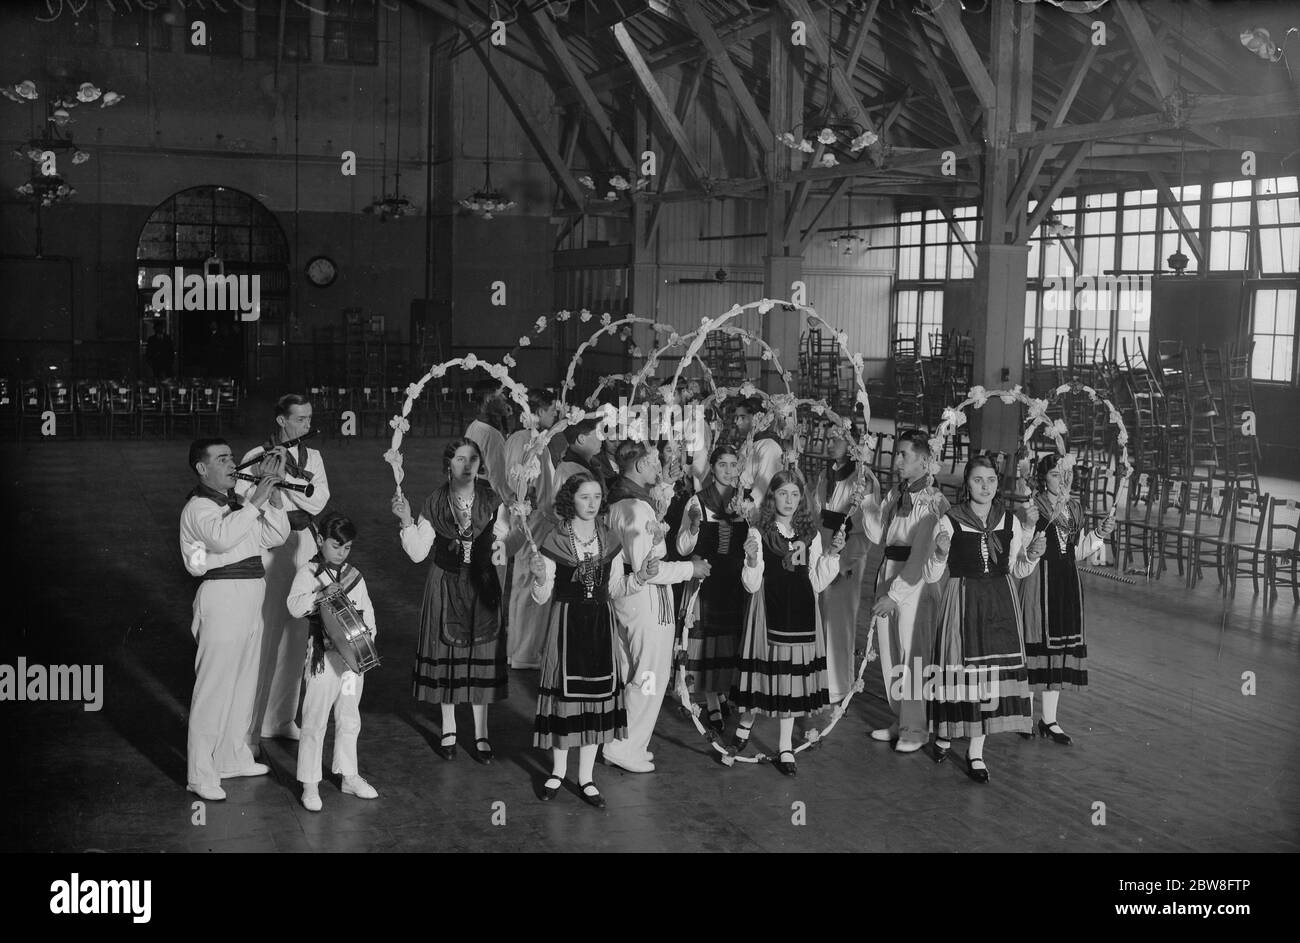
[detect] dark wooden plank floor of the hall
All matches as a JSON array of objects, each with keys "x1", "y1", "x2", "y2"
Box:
[{"x1": 0, "y1": 437, "x2": 1300, "y2": 852}]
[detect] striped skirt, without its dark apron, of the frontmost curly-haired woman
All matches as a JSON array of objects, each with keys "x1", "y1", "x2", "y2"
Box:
[{"x1": 533, "y1": 602, "x2": 628, "y2": 749}]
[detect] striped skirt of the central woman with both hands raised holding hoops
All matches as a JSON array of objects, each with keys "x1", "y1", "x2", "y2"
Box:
[{"x1": 731, "y1": 592, "x2": 831, "y2": 718}]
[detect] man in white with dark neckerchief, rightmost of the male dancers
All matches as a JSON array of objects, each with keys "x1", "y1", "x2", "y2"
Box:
[{"x1": 862, "y1": 431, "x2": 948, "y2": 756}]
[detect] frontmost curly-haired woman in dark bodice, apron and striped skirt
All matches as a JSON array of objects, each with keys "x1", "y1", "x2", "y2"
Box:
[{"x1": 530, "y1": 472, "x2": 658, "y2": 809}]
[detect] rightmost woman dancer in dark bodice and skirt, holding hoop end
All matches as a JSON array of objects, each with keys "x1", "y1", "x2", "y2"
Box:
[{"x1": 1021, "y1": 454, "x2": 1115, "y2": 744}]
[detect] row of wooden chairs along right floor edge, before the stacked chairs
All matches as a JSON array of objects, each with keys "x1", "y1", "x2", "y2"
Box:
[{"x1": 1088, "y1": 473, "x2": 1300, "y2": 604}]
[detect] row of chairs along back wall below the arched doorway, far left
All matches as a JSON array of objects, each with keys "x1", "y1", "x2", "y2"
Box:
[{"x1": 0, "y1": 377, "x2": 241, "y2": 441}]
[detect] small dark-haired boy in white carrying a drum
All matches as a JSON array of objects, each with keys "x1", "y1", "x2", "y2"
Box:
[{"x1": 289, "y1": 511, "x2": 380, "y2": 812}]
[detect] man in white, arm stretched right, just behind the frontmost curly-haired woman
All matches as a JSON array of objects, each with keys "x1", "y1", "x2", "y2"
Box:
[{"x1": 605, "y1": 440, "x2": 710, "y2": 773}]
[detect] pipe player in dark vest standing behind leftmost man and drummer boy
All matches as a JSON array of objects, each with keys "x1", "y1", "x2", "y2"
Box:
[{"x1": 235, "y1": 393, "x2": 329, "y2": 740}]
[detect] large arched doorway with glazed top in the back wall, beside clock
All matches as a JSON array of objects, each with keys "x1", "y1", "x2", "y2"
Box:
[{"x1": 135, "y1": 186, "x2": 289, "y2": 386}]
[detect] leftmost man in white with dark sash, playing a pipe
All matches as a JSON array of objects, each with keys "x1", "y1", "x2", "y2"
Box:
[{"x1": 179, "y1": 438, "x2": 290, "y2": 801}]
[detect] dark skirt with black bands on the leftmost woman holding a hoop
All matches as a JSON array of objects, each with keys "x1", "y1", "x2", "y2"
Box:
[{"x1": 411, "y1": 567, "x2": 510, "y2": 704}]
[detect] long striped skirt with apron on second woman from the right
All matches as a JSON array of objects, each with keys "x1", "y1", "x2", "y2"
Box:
[{"x1": 923, "y1": 576, "x2": 1034, "y2": 740}]
